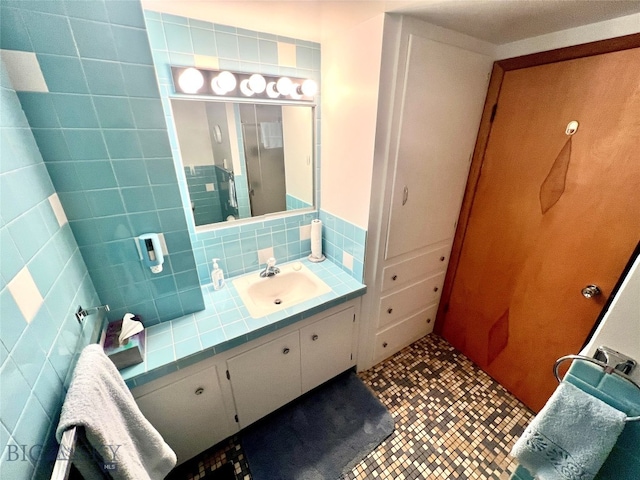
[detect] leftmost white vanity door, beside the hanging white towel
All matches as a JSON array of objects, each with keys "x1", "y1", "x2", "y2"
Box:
[{"x1": 136, "y1": 367, "x2": 235, "y2": 464}]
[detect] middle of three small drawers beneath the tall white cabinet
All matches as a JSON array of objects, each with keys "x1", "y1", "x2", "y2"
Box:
[{"x1": 378, "y1": 272, "x2": 445, "y2": 328}]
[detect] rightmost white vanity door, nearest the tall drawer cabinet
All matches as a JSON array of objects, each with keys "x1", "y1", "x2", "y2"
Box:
[{"x1": 300, "y1": 307, "x2": 354, "y2": 393}]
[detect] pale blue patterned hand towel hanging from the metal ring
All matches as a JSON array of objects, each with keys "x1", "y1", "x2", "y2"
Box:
[{"x1": 511, "y1": 382, "x2": 626, "y2": 480}]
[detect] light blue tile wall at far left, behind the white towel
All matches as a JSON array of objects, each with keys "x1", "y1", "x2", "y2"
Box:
[{"x1": 0, "y1": 57, "x2": 99, "y2": 480}]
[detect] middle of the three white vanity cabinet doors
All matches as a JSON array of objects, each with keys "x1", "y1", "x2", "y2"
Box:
[{"x1": 227, "y1": 331, "x2": 301, "y2": 428}]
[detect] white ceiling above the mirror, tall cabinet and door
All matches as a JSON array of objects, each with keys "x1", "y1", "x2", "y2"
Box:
[{"x1": 142, "y1": 0, "x2": 640, "y2": 45}]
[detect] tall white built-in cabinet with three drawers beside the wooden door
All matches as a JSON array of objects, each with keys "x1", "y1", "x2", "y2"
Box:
[{"x1": 358, "y1": 15, "x2": 493, "y2": 369}]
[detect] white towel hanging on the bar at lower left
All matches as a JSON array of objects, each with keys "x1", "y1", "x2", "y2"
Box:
[{"x1": 56, "y1": 344, "x2": 176, "y2": 480}]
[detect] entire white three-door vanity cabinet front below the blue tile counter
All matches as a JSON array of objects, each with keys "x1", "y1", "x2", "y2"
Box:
[{"x1": 132, "y1": 298, "x2": 360, "y2": 454}]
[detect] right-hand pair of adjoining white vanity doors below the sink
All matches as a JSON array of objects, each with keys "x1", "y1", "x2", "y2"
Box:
[{"x1": 227, "y1": 304, "x2": 356, "y2": 428}]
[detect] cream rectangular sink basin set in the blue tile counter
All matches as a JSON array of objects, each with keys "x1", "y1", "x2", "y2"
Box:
[{"x1": 233, "y1": 262, "x2": 331, "y2": 318}]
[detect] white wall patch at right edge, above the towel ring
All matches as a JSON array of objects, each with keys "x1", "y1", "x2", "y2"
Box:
[{"x1": 580, "y1": 257, "x2": 640, "y2": 382}]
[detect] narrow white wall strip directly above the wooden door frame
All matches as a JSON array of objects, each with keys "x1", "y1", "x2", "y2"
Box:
[{"x1": 496, "y1": 13, "x2": 640, "y2": 60}]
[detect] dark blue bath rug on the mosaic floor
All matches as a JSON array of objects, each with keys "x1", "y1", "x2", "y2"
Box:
[{"x1": 241, "y1": 371, "x2": 394, "y2": 480}]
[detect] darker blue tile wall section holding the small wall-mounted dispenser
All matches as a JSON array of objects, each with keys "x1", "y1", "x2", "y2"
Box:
[{"x1": 1, "y1": 0, "x2": 204, "y2": 325}]
